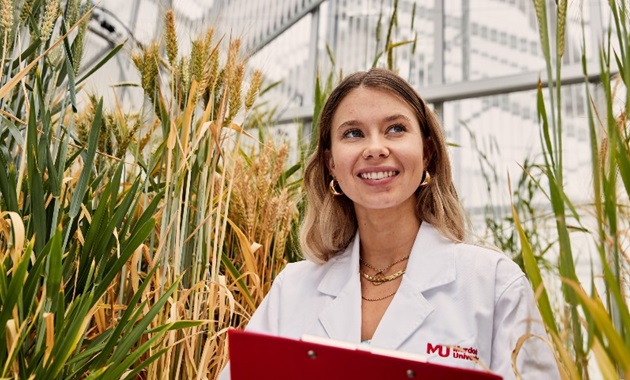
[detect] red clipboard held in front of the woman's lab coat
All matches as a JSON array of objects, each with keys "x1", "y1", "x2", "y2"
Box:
[{"x1": 228, "y1": 329, "x2": 502, "y2": 380}]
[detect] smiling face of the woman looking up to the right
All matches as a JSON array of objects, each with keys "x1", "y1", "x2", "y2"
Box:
[{"x1": 327, "y1": 87, "x2": 426, "y2": 215}]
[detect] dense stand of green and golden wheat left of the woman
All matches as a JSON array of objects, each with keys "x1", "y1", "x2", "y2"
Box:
[{"x1": 0, "y1": 0, "x2": 299, "y2": 379}]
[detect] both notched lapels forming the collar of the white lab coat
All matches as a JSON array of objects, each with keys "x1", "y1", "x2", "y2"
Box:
[{"x1": 318, "y1": 222, "x2": 456, "y2": 349}]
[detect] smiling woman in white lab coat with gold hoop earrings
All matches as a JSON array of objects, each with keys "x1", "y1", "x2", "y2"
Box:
[{"x1": 220, "y1": 69, "x2": 558, "y2": 379}]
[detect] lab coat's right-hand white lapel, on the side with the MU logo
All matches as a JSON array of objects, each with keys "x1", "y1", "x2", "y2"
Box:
[{"x1": 372, "y1": 222, "x2": 456, "y2": 350}]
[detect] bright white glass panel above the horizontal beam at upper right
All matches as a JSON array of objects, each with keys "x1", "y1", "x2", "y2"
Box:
[{"x1": 444, "y1": 0, "x2": 601, "y2": 83}]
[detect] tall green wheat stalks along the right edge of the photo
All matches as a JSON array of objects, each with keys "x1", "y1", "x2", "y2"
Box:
[{"x1": 513, "y1": 0, "x2": 630, "y2": 379}]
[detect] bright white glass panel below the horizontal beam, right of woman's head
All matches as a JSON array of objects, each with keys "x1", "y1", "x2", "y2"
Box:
[{"x1": 443, "y1": 84, "x2": 592, "y2": 226}]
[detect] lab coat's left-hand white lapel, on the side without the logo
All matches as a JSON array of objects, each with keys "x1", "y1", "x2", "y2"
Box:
[{"x1": 318, "y1": 234, "x2": 361, "y2": 343}]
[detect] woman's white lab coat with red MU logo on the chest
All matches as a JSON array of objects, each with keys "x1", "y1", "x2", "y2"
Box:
[{"x1": 220, "y1": 222, "x2": 559, "y2": 379}]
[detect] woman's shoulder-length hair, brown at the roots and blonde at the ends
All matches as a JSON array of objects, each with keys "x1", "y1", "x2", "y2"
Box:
[{"x1": 300, "y1": 68, "x2": 465, "y2": 263}]
